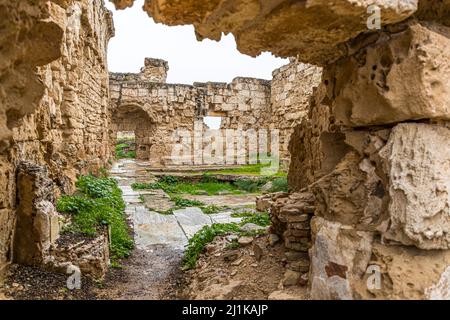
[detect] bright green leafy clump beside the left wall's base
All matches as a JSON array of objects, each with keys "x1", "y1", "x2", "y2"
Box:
[{"x1": 57, "y1": 175, "x2": 133, "y2": 263}]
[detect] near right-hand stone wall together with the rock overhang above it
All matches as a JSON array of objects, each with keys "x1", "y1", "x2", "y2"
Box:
[{"x1": 121, "y1": 0, "x2": 450, "y2": 299}]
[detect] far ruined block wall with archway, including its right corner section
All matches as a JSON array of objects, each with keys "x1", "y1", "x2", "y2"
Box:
[{"x1": 110, "y1": 58, "x2": 321, "y2": 168}]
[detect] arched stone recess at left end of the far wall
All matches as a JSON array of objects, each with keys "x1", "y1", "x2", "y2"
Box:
[{"x1": 112, "y1": 104, "x2": 155, "y2": 160}]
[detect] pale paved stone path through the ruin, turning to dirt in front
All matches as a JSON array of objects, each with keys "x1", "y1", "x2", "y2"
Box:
[{"x1": 103, "y1": 159, "x2": 244, "y2": 300}]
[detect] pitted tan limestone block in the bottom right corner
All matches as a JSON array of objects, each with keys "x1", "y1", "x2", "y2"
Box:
[{"x1": 352, "y1": 241, "x2": 450, "y2": 300}]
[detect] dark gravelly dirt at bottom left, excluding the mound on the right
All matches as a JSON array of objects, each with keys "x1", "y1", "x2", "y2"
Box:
[{"x1": 0, "y1": 246, "x2": 184, "y2": 300}]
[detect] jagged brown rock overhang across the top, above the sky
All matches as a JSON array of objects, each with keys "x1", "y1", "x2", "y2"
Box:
[{"x1": 111, "y1": 0, "x2": 418, "y2": 65}]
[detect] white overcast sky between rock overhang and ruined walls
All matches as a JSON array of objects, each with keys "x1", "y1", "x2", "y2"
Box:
[{"x1": 106, "y1": 0, "x2": 289, "y2": 84}]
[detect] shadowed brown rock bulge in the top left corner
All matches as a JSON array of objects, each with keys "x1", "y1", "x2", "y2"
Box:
[{"x1": 0, "y1": 0, "x2": 64, "y2": 152}]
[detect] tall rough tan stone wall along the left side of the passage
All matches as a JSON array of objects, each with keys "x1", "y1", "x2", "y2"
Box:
[{"x1": 0, "y1": 0, "x2": 113, "y2": 280}]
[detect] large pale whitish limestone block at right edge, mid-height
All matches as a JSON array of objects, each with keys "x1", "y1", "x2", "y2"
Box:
[{"x1": 380, "y1": 123, "x2": 450, "y2": 249}]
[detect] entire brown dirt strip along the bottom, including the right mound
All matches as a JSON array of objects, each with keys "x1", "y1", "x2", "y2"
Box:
[{"x1": 0, "y1": 235, "x2": 308, "y2": 300}]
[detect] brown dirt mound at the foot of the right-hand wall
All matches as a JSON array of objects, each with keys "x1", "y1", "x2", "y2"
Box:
[{"x1": 182, "y1": 235, "x2": 308, "y2": 300}]
